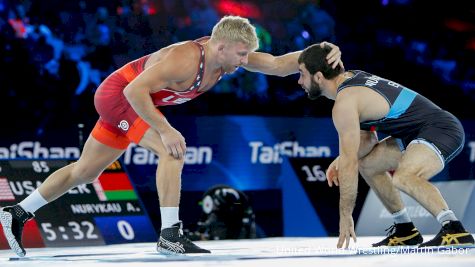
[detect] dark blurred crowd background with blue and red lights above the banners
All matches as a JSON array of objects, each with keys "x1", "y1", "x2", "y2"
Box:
[{"x1": 0, "y1": 0, "x2": 475, "y2": 138}]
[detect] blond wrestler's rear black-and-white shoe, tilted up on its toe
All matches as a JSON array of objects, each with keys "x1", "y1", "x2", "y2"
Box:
[{"x1": 0, "y1": 205, "x2": 35, "y2": 257}]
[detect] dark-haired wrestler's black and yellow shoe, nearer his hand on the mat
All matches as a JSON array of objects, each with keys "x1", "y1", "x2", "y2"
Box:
[{"x1": 373, "y1": 222, "x2": 422, "y2": 247}]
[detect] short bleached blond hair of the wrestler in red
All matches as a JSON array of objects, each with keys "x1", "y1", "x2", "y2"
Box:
[{"x1": 211, "y1": 16, "x2": 259, "y2": 51}]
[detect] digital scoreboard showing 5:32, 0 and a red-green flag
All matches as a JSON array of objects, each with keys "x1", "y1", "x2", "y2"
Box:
[{"x1": 0, "y1": 160, "x2": 157, "y2": 249}]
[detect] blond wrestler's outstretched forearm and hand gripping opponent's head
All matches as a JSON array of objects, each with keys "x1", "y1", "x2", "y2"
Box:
[{"x1": 243, "y1": 42, "x2": 343, "y2": 77}]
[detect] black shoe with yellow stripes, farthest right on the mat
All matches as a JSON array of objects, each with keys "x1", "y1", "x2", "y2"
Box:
[{"x1": 419, "y1": 221, "x2": 474, "y2": 247}]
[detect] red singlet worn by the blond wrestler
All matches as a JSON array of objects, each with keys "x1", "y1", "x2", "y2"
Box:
[{"x1": 92, "y1": 39, "x2": 221, "y2": 149}]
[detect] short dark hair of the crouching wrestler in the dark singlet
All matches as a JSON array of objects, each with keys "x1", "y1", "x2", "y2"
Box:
[{"x1": 298, "y1": 44, "x2": 344, "y2": 79}]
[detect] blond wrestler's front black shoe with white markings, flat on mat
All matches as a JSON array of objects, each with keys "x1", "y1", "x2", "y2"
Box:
[{"x1": 157, "y1": 221, "x2": 211, "y2": 254}]
